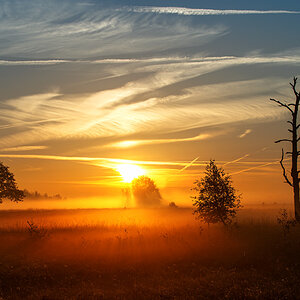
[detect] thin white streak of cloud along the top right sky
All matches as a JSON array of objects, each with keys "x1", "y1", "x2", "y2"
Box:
[{"x1": 127, "y1": 6, "x2": 300, "y2": 16}]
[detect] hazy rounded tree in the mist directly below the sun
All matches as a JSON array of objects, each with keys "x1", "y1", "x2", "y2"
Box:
[{"x1": 132, "y1": 176, "x2": 162, "y2": 207}]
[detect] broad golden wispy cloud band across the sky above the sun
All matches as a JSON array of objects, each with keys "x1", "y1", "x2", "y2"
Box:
[{"x1": 0, "y1": 62, "x2": 292, "y2": 148}]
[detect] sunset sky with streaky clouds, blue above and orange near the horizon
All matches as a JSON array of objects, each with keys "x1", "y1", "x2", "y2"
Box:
[{"x1": 0, "y1": 0, "x2": 300, "y2": 207}]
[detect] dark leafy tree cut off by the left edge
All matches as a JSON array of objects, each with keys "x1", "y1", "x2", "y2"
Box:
[{"x1": 0, "y1": 162, "x2": 24, "y2": 203}]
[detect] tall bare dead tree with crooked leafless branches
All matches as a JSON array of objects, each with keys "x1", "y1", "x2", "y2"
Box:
[{"x1": 270, "y1": 77, "x2": 300, "y2": 222}]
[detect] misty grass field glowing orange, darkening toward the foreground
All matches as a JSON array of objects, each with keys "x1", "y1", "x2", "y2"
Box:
[{"x1": 0, "y1": 207, "x2": 300, "y2": 299}]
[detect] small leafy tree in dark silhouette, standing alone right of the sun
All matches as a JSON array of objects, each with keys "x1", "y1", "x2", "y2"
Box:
[{"x1": 192, "y1": 160, "x2": 241, "y2": 225}]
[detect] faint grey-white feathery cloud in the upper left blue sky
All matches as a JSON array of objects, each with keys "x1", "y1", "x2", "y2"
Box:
[{"x1": 0, "y1": 0, "x2": 226, "y2": 59}]
